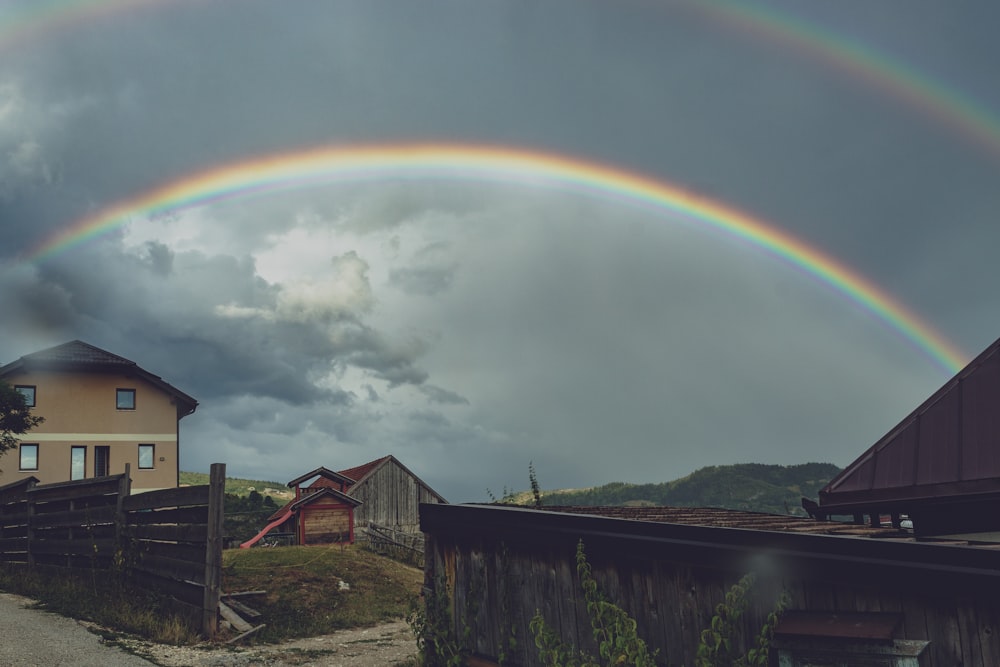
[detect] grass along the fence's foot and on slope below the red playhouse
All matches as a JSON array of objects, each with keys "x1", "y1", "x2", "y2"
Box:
[{"x1": 0, "y1": 545, "x2": 423, "y2": 644}]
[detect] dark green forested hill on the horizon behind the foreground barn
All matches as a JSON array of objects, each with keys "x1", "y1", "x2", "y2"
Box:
[{"x1": 536, "y1": 463, "x2": 840, "y2": 515}]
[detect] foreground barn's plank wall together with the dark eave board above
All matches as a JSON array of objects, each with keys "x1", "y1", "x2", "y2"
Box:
[{"x1": 424, "y1": 506, "x2": 1000, "y2": 667}]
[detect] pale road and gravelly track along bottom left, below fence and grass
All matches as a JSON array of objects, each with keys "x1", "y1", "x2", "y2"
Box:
[{"x1": 0, "y1": 593, "x2": 417, "y2": 667}]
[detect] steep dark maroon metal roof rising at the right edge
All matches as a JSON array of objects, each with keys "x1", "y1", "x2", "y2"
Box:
[{"x1": 811, "y1": 340, "x2": 1000, "y2": 529}]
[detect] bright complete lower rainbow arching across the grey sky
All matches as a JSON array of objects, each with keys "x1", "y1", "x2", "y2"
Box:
[{"x1": 26, "y1": 144, "x2": 967, "y2": 374}]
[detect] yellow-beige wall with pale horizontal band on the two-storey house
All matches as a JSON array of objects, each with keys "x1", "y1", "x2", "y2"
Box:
[{"x1": 0, "y1": 372, "x2": 179, "y2": 492}]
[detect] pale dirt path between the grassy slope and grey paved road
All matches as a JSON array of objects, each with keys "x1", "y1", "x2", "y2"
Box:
[{"x1": 118, "y1": 621, "x2": 417, "y2": 667}]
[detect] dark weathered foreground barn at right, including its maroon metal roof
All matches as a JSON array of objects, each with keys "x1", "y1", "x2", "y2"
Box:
[{"x1": 421, "y1": 341, "x2": 1000, "y2": 667}]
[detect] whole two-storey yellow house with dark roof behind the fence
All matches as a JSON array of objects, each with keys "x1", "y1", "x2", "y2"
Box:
[{"x1": 0, "y1": 340, "x2": 198, "y2": 493}]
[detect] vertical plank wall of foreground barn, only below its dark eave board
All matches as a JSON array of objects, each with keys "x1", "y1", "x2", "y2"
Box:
[{"x1": 425, "y1": 535, "x2": 1000, "y2": 667}]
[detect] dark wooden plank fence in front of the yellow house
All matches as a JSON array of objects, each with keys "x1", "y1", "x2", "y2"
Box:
[{"x1": 0, "y1": 463, "x2": 226, "y2": 636}]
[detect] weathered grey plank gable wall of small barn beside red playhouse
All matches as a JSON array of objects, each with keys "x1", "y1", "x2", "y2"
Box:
[{"x1": 349, "y1": 459, "x2": 440, "y2": 533}]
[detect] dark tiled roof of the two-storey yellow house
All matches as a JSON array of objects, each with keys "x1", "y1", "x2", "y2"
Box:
[{"x1": 0, "y1": 340, "x2": 198, "y2": 418}]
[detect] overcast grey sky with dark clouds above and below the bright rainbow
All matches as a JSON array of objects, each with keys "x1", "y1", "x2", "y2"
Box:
[{"x1": 0, "y1": 0, "x2": 1000, "y2": 501}]
